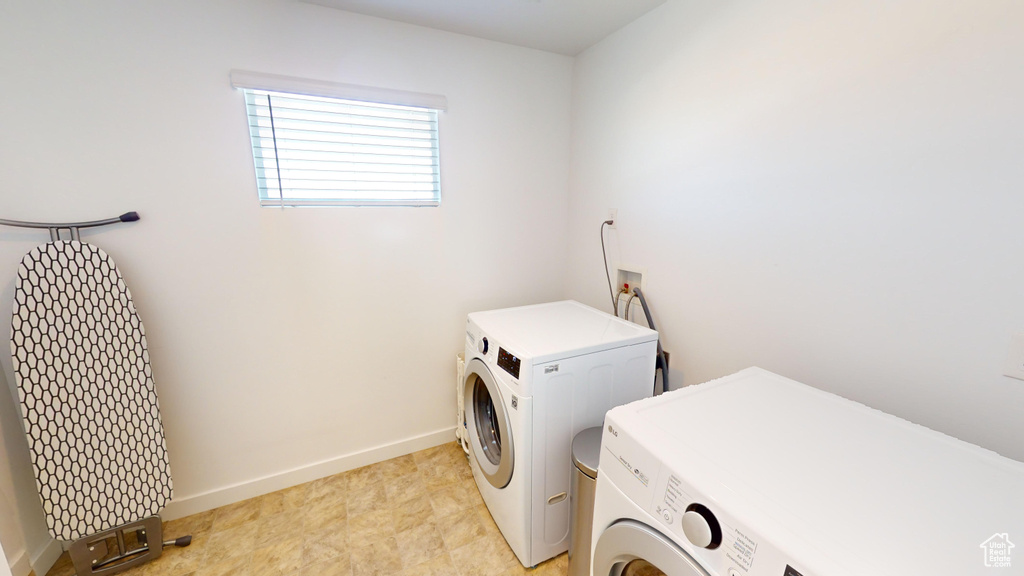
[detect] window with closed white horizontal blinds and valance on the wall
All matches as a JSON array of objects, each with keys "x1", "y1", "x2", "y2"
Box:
[{"x1": 231, "y1": 72, "x2": 446, "y2": 206}]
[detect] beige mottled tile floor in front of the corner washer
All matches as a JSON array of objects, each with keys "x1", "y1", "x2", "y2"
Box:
[{"x1": 47, "y1": 443, "x2": 568, "y2": 576}]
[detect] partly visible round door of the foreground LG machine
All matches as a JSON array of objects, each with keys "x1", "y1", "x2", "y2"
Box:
[{"x1": 594, "y1": 520, "x2": 709, "y2": 576}]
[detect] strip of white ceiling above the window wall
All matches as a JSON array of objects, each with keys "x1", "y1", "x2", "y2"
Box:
[{"x1": 303, "y1": 0, "x2": 666, "y2": 56}]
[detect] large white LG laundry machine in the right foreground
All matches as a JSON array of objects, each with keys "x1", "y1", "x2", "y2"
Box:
[{"x1": 592, "y1": 368, "x2": 1024, "y2": 576}]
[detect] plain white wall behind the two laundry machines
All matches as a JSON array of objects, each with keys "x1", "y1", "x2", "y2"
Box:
[{"x1": 568, "y1": 0, "x2": 1024, "y2": 460}]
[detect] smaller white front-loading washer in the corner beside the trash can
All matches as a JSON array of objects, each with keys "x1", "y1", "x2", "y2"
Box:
[{"x1": 463, "y1": 301, "x2": 657, "y2": 567}]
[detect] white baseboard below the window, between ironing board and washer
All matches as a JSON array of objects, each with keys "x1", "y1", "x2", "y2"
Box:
[{"x1": 160, "y1": 426, "x2": 455, "y2": 520}]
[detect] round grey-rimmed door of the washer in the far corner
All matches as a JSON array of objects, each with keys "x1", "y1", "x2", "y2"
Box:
[{"x1": 463, "y1": 358, "x2": 514, "y2": 488}]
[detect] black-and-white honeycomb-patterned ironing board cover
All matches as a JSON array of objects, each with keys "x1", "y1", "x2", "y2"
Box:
[{"x1": 10, "y1": 241, "x2": 171, "y2": 540}]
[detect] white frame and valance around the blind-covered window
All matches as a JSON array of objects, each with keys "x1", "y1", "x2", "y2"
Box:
[{"x1": 231, "y1": 71, "x2": 447, "y2": 207}]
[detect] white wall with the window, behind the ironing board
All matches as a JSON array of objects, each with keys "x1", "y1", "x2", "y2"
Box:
[{"x1": 0, "y1": 0, "x2": 572, "y2": 565}]
